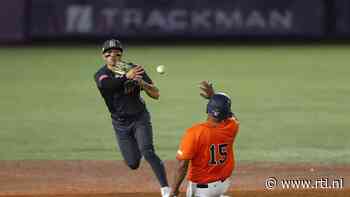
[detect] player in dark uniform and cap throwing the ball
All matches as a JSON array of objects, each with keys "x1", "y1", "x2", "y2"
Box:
[{"x1": 95, "y1": 39, "x2": 170, "y2": 197}]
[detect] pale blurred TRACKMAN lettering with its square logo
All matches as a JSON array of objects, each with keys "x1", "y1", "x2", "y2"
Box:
[{"x1": 66, "y1": 5, "x2": 294, "y2": 33}]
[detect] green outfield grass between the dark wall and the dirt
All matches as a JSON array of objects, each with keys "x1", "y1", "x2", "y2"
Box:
[{"x1": 0, "y1": 45, "x2": 350, "y2": 163}]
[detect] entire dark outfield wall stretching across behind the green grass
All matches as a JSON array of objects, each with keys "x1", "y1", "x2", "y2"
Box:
[{"x1": 0, "y1": 0, "x2": 350, "y2": 42}]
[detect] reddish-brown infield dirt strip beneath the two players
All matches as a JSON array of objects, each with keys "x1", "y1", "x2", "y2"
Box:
[{"x1": 0, "y1": 160, "x2": 350, "y2": 197}]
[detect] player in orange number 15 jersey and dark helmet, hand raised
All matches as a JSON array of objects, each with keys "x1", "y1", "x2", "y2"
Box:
[{"x1": 170, "y1": 82, "x2": 239, "y2": 197}]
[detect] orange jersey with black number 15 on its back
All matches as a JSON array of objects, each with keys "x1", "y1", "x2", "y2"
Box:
[{"x1": 176, "y1": 118, "x2": 239, "y2": 183}]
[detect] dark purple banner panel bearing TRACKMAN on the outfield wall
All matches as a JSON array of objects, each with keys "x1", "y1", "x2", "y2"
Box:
[{"x1": 31, "y1": 0, "x2": 324, "y2": 37}]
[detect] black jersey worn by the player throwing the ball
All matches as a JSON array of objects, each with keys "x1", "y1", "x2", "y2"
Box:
[{"x1": 94, "y1": 65, "x2": 153, "y2": 118}]
